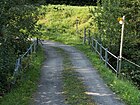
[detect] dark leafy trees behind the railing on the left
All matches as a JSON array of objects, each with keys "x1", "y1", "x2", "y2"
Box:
[{"x1": 0, "y1": 0, "x2": 38, "y2": 96}]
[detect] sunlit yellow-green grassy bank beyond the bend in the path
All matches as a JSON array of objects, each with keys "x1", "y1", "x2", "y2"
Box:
[{"x1": 38, "y1": 5, "x2": 97, "y2": 44}]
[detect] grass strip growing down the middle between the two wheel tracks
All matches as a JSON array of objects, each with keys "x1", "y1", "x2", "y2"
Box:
[{"x1": 55, "y1": 49, "x2": 95, "y2": 105}]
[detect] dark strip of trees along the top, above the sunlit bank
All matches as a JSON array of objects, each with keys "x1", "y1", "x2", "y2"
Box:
[{"x1": 46, "y1": 0, "x2": 97, "y2": 6}]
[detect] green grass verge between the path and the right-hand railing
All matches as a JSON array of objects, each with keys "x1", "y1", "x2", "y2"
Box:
[{"x1": 76, "y1": 45, "x2": 140, "y2": 105}]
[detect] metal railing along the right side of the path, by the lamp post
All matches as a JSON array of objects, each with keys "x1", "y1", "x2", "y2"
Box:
[{"x1": 83, "y1": 29, "x2": 140, "y2": 74}]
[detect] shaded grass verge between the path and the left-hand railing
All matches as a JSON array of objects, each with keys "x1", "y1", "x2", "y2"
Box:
[{"x1": 0, "y1": 48, "x2": 44, "y2": 105}]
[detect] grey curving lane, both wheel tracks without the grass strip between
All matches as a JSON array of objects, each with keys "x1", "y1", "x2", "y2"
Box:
[{"x1": 31, "y1": 41, "x2": 124, "y2": 105}]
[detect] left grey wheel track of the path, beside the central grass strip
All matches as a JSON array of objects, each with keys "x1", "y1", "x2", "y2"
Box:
[{"x1": 32, "y1": 45, "x2": 65, "y2": 105}]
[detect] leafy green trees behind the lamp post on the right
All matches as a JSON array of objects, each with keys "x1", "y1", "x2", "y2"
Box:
[{"x1": 91, "y1": 0, "x2": 140, "y2": 86}]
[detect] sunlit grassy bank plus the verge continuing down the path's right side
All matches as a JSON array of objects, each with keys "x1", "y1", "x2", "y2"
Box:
[{"x1": 37, "y1": 5, "x2": 140, "y2": 105}]
